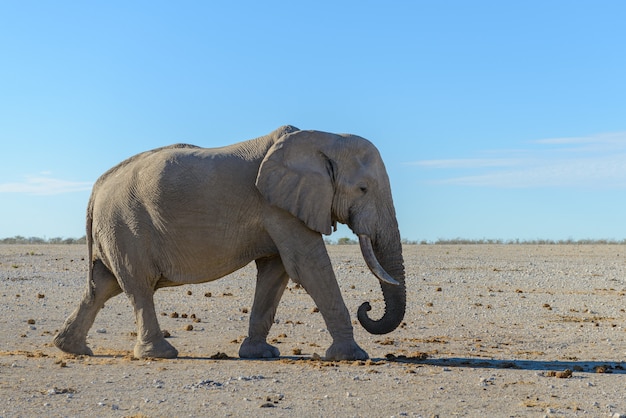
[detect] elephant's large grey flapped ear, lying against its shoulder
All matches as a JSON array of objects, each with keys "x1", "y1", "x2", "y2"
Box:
[{"x1": 256, "y1": 131, "x2": 334, "y2": 235}]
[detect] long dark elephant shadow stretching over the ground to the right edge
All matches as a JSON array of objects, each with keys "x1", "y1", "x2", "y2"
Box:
[{"x1": 392, "y1": 357, "x2": 626, "y2": 374}]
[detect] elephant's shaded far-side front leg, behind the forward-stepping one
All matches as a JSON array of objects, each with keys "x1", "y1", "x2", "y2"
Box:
[{"x1": 239, "y1": 256, "x2": 289, "y2": 358}]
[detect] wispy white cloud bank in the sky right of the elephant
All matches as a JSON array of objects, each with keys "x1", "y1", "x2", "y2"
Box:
[{"x1": 411, "y1": 132, "x2": 626, "y2": 188}]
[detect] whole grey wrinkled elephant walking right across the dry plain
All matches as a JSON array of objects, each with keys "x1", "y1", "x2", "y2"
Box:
[{"x1": 54, "y1": 126, "x2": 406, "y2": 360}]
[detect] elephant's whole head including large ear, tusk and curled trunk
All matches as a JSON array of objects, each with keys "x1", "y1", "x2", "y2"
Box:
[{"x1": 257, "y1": 131, "x2": 406, "y2": 334}]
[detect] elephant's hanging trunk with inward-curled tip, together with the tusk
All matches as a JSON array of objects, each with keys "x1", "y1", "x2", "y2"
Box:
[{"x1": 357, "y1": 234, "x2": 406, "y2": 334}]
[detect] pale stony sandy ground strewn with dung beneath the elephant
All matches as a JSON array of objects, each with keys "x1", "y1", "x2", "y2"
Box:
[{"x1": 0, "y1": 245, "x2": 626, "y2": 417}]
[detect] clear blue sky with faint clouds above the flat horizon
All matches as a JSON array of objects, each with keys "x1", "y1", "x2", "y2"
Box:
[{"x1": 0, "y1": 0, "x2": 626, "y2": 240}]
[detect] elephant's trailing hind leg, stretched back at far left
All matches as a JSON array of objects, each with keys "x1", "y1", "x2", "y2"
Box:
[{"x1": 54, "y1": 260, "x2": 122, "y2": 356}]
